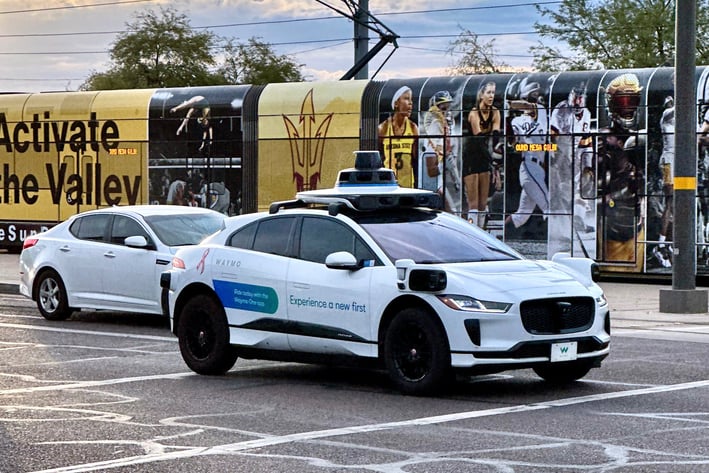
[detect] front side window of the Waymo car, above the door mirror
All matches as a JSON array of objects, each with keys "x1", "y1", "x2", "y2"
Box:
[{"x1": 300, "y1": 217, "x2": 375, "y2": 264}]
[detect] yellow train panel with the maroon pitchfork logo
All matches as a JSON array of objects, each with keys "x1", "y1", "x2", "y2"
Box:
[{"x1": 258, "y1": 81, "x2": 367, "y2": 209}]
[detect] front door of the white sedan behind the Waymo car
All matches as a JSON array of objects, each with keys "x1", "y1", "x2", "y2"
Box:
[{"x1": 101, "y1": 215, "x2": 165, "y2": 314}]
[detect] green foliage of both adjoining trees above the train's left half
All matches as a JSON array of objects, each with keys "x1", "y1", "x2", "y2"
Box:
[{"x1": 80, "y1": 7, "x2": 302, "y2": 90}]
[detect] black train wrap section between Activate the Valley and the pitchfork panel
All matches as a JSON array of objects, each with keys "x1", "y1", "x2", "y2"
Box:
[{"x1": 149, "y1": 86, "x2": 249, "y2": 215}]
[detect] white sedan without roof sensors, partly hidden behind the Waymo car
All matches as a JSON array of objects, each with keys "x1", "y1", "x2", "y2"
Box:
[{"x1": 20, "y1": 205, "x2": 226, "y2": 320}]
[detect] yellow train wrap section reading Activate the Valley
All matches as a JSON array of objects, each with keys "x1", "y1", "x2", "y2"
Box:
[{"x1": 0, "y1": 91, "x2": 149, "y2": 247}]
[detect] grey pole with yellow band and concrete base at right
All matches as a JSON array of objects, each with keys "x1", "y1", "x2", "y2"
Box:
[{"x1": 660, "y1": 0, "x2": 707, "y2": 314}]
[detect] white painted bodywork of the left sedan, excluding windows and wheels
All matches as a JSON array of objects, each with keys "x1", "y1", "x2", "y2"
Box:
[{"x1": 19, "y1": 205, "x2": 226, "y2": 314}]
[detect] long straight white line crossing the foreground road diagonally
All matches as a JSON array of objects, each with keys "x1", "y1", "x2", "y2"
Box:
[{"x1": 27, "y1": 380, "x2": 709, "y2": 473}]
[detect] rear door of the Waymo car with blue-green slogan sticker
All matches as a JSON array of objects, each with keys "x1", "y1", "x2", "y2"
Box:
[{"x1": 209, "y1": 216, "x2": 296, "y2": 350}]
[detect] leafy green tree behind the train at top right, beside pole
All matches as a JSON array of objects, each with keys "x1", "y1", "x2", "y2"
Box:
[{"x1": 530, "y1": 0, "x2": 709, "y2": 70}]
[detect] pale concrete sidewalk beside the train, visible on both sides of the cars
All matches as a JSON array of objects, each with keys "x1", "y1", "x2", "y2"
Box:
[{"x1": 0, "y1": 251, "x2": 709, "y2": 328}]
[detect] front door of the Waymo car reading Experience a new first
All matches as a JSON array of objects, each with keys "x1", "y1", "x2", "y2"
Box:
[{"x1": 288, "y1": 216, "x2": 376, "y2": 354}]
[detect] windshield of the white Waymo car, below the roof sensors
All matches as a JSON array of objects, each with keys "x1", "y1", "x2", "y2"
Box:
[{"x1": 355, "y1": 210, "x2": 522, "y2": 263}]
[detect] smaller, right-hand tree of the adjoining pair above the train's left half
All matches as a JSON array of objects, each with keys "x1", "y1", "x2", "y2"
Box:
[{"x1": 219, "y1": 38, "x2": 303, "y2": 84}]
